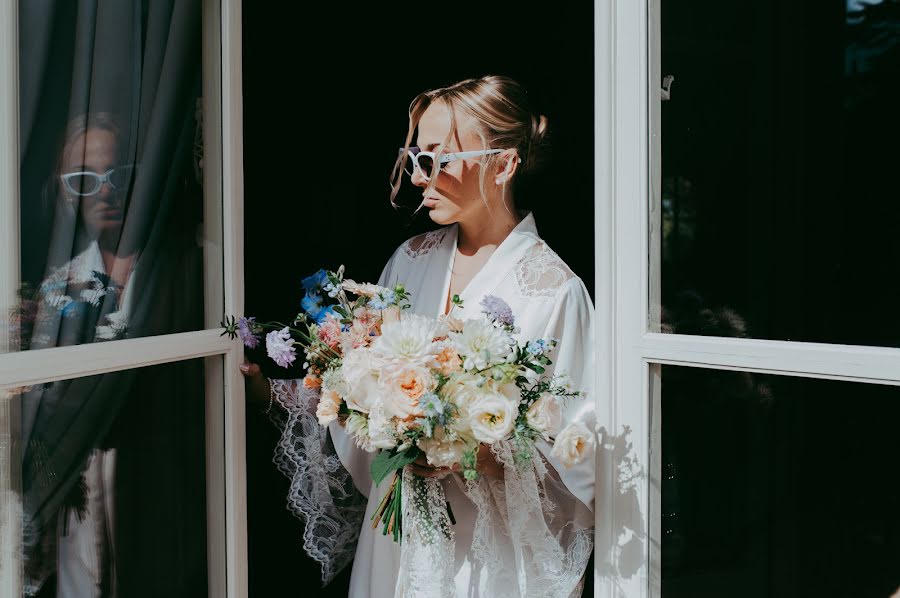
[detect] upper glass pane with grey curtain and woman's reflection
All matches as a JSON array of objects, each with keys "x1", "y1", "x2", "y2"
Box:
[{"x1": 7, "y1": 0, "x2": 203, "y2": 350}]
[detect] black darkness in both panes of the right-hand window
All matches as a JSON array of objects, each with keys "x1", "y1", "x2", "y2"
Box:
[{"x1": 662, "y1": 0, "x2": 900, "y2": 598}]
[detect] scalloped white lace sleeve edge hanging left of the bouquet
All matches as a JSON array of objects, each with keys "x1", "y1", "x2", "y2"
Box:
[{"x1": 270, "y1": 380, "x2": 366, "y2": 584}]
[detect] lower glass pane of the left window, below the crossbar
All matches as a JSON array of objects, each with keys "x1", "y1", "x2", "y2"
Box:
[{"x1": 0, "y1": 359, "x2": 211, "y2": 598}]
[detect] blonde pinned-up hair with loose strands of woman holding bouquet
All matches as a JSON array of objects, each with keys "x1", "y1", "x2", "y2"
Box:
[{"x1": 390, "y1": 75, "x2": 548, "y2": 206}]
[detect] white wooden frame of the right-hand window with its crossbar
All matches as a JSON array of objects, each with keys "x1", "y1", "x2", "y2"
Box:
[{"x1": 594, "y1": 0, "x2": 900, "y2": 598}]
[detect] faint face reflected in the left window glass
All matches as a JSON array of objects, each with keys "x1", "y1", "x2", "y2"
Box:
[{"x1": 62, "y1": 129, "x2": 127, "y2": 237}]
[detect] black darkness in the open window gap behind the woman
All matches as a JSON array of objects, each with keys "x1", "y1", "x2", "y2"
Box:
[{"x1": 243, "y1": 2, "x2": 594, "y2": 596}]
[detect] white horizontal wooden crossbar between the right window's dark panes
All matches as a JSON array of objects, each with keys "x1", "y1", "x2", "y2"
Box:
[{"x1": 638, "y1": 334, "x2": 900, "y2": 385}]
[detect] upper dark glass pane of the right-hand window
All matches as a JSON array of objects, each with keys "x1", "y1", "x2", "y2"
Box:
[{"x1": 653, "y1": 0, "x2": 900, "y2": 347}]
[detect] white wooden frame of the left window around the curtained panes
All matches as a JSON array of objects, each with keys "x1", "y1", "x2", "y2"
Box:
[{"x1": 0, "y1": 0, "x2": 247, "y2": 598}]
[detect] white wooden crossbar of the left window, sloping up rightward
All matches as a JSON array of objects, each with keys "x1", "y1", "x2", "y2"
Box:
[{"x1": 0, "y1": 329, "x2": 235, "y2": 390}]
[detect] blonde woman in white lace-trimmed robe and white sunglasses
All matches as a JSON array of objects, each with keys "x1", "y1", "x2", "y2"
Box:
[{"x1": 241, "y1": 76, "x2": 594, "y2": 598}]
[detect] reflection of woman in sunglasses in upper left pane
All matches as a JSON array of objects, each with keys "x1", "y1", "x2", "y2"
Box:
[{"x1": 31, "y1": 113, "x2": 137, "y2": 348}]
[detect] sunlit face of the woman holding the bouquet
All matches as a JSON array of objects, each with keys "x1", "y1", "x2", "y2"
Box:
[{"x1": 411, "y1": 102, "x2": 494, "y2": 225}]
